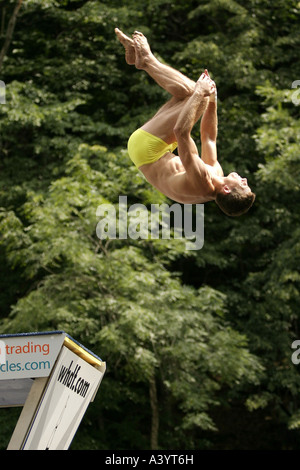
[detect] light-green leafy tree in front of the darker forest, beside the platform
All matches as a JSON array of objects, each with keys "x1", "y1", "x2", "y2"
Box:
[{"x1": 1, "y1": 144, "x2": 261, "y2": 448}]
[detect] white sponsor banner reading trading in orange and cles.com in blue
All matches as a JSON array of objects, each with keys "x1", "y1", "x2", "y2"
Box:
[{"x1": 0, "y1": 332, "x2": 66, "y2": 380}]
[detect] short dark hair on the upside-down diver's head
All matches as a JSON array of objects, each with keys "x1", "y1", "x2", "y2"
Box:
[{"x1": 216, "y1": 188, "x2": 255, "y2": 217}]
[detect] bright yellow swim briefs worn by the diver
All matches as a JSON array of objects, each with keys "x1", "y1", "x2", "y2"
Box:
[{"x1": 128, "y1": 129, "x2": 178, "y2": 168}]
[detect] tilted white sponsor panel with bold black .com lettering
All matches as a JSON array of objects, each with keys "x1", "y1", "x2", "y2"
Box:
[{"x1": 22, "y1": 346, "x2": 105, "y2": 450}]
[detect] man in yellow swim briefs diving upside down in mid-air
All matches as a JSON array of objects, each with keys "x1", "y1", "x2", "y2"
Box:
[{"x1": 115, "y1": 28, "x2": 255, "y2": 216}]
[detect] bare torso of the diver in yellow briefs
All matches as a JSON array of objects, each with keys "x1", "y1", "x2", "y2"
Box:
[{"x1": 139, "y1": 152, "x2": 215, "y2": 204}]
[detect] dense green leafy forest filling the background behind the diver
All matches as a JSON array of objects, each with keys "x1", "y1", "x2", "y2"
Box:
[{"x1": 0, "y1": 0, "x2": 300, "y2": 450}]
